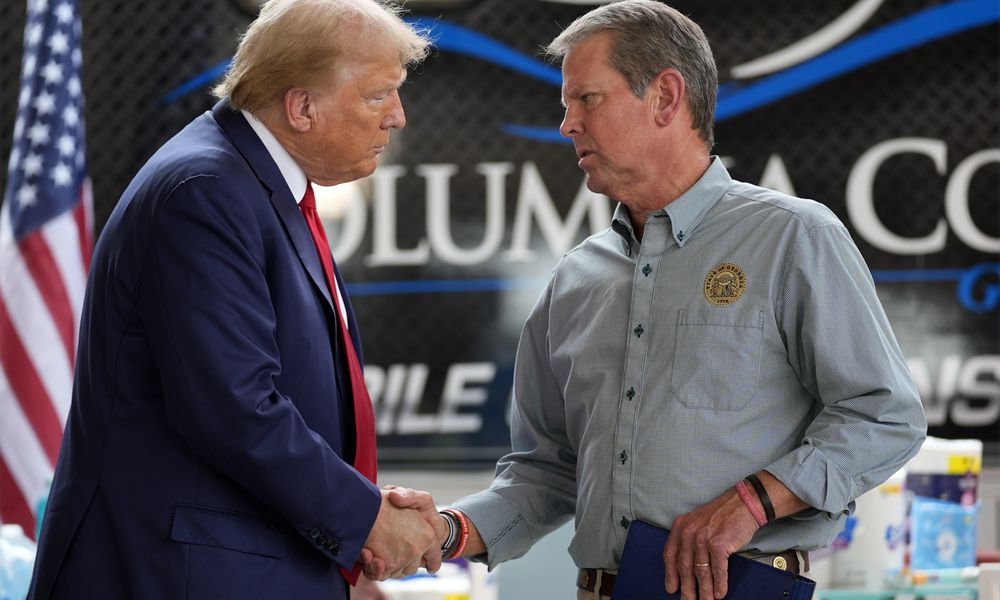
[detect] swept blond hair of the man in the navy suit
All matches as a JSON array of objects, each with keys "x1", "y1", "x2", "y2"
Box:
[{"x1": 212, "y1": 0, "x2": 429, "y2": 113}]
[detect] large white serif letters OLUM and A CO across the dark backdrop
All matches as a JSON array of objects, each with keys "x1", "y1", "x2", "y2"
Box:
[{"x1": 333, "y1": 137, "x2": 1000, "y2": 267}]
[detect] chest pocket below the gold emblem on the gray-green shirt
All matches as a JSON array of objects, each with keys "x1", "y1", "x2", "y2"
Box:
[{"x1": 670, "y1": 307, "x2": 764, "y2": 411}]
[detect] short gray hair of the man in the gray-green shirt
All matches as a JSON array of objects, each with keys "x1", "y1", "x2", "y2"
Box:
[{"x1": 545, "y1": 0, "x2": 719, "y2": 149}]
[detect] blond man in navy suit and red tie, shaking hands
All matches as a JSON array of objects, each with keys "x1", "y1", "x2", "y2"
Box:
[{"x1": 29, "y1": 0, "x2": 440, "y2": 600}]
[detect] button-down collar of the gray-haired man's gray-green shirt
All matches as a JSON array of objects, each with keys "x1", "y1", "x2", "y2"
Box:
[{"x1": 611, "y1": 156, "x2": 733, "y2": 252}]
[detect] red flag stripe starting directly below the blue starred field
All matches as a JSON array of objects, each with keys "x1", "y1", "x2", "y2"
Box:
[{"x1": 17, "y1": 230, "x2": 76, "y2": 369}]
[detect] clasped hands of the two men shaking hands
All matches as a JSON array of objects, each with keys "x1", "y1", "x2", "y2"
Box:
[{"x1": 358, "y1": 485, "x2": 458, "y2": 581}]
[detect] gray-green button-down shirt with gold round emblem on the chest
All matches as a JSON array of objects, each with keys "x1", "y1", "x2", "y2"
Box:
[{"x1": 456, "y1": 158, "x2": 927, "y2": 569}]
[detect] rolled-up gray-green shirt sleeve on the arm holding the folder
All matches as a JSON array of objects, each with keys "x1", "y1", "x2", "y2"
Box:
[{"x1": 766, "y1": 223, "x2": 927, "y2": 514}]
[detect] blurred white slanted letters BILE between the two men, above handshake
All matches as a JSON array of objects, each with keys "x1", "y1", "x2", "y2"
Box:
[{"x1": 365, "y1": 362, "x2": 497, "y2": 435}]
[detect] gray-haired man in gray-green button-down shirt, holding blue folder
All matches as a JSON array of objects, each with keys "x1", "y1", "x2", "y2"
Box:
[{"x1": 364, "y1": 0, "x2": 926, "y2": 600}]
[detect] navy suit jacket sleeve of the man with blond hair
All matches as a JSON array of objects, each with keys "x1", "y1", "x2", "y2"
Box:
[{"x1": 139, "y1": 175, "x2": 380, "y2": 568}]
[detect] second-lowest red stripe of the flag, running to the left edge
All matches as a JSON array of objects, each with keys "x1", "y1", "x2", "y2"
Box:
[{"x1": 0, "y1": 297, "x2": 62, "y2": 465}]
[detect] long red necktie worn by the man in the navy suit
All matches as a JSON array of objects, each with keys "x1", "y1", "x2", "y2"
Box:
[{"x1": 299, "y1": 183, "x2": 378, "y2": 585}]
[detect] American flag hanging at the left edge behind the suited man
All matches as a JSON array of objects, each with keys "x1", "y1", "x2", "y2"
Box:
[{"x1": 0, "y1": 0, "x2": 92, "y2": 535}]
